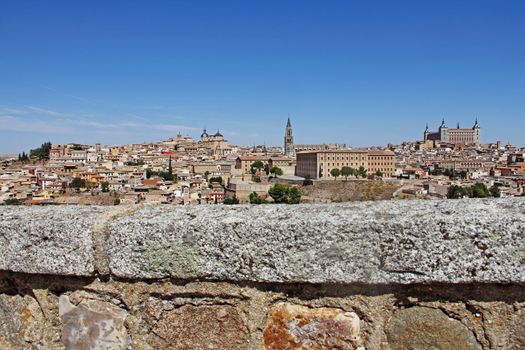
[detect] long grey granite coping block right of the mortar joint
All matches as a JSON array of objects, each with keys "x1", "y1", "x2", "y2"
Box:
[{"x1": 108, "y1": 198, "x2": 525, "y2": 283}]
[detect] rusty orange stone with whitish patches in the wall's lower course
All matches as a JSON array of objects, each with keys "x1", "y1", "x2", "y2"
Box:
[{"x1": 264, "y1": 303, "x2": 360, "y2": 350}]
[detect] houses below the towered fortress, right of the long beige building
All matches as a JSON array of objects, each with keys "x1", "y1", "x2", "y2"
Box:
[{"x1": 394, "y1": 141, "x2": 525, "y2": 197}]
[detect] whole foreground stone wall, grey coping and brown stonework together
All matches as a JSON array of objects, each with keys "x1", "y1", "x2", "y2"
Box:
[{"x1": 0, "y1": 198, "x2": 525, "y2": 349}]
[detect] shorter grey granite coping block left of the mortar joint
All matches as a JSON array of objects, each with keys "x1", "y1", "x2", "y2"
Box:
[{"x1": 0, "y1": 206, "x2": 103, "y2": 276}]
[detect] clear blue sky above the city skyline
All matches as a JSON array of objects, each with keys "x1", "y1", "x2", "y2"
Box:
[{"x1": 0, "y1": 0, "x2": 525, "y2": 153}]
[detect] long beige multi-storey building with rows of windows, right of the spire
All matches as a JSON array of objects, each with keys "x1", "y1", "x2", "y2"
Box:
[{"x1": 295, "y1": 149, "x2": 396, "y2": 179}]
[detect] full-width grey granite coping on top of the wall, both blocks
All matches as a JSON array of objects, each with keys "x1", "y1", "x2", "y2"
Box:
[{"x1": 0, "y1": 198, "x2": 525, "y2": 284}]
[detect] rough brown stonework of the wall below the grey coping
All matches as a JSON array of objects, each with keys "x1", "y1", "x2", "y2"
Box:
[{"x1": 0, "y1": 273, "x2": 525, "y2": 350}]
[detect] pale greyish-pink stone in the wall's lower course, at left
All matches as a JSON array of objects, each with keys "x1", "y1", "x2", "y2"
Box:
[{"x1": 59, "y1": 295, "x2": 128, "y2": 350}]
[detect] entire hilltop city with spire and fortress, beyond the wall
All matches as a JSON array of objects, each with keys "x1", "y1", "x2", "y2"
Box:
[{"x1": 0, "y1": 117, "x2": 525, "y2": 205}]
